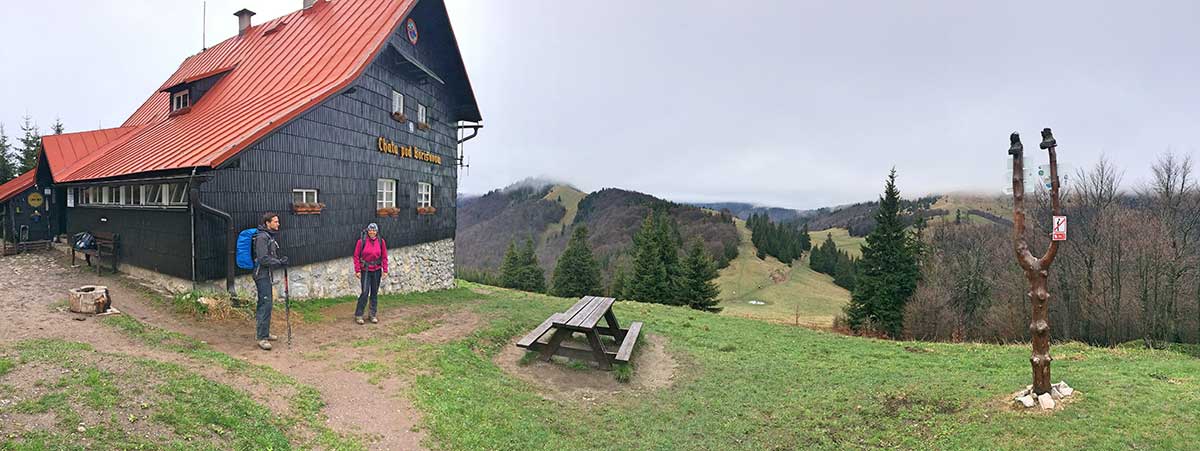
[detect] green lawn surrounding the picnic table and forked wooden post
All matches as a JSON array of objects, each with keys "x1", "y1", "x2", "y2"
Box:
[{"x1": 384, "y1": 283, "x2": 1200, "y2": 450}]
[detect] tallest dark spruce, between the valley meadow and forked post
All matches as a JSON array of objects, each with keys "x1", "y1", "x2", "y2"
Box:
[{"x1": 845, "y1": 169, "x2": 920, "y2": 338}]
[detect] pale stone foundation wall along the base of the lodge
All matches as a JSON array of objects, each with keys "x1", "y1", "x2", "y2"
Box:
[{"x1": 66, "y1": 239, "x2": 454, "y2": 300}]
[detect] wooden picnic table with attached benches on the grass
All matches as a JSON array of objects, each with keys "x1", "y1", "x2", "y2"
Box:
[{"x1": 517, "y1": 296, "x2": 642, "y2": 369}]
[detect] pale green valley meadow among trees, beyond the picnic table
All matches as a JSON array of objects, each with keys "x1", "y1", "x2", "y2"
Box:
[{"x1": 716, "y1": 221, "x2": 850, "y2": 326}]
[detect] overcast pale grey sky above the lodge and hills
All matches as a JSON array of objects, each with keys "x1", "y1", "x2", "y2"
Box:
[{"x1": 0, "y1": 0, "x2": 1200, "y2": 208}]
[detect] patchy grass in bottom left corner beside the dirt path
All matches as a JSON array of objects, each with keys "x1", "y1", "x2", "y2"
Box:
[{"x1": 0, "y1": 339, "x2": 290, "y2": 450}]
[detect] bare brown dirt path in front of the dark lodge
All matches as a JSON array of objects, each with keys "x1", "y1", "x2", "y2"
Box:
[{"x1": 0, "y1": 252, "x2": 424, "y2": 450}]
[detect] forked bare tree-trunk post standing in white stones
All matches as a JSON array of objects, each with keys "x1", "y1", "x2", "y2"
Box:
[{"x1": 1008, "y1": 128, "x2": 1060, "y2": 396}]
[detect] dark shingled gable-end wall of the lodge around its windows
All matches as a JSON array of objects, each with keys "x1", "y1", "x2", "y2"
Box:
[{"x1": 190, "y1": 3, "x2": 458, "y2": 279}]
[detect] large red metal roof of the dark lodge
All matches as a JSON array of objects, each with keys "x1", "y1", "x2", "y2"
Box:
[{"x1": 56, "y1": 0, "x2": 415, "y2": 182}]
